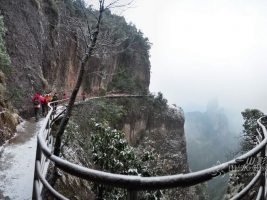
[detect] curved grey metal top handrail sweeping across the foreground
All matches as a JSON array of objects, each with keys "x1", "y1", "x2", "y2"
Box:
[{"x1": 31, "y1": 97, "x2": 267, "y2": 199}]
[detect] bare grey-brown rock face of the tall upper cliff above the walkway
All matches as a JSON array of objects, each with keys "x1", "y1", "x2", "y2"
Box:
[{"x1": 0, "y1": 0, "x2": 150, "y2": 117}]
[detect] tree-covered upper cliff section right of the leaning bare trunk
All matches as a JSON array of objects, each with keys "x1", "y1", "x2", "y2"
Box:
[{"x1": 64, "y1": 0, "x2": 151, "y2": 94}]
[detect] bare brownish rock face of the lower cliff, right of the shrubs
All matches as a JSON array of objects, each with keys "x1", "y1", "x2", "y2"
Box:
[{"x1": 124, "y1": 107, "x2": 197, "y2": 200}]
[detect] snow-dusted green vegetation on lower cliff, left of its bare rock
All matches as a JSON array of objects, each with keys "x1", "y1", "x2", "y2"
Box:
[{"x1": 55, "y1": 96, "x2": 171, "y2": 199}]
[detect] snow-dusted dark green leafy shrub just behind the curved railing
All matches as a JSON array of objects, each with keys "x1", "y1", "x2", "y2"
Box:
[{"x1": 91, "y1": 119, "x2": 162, "y2": 200}]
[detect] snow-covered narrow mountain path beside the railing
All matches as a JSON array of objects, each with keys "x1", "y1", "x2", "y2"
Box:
[{"x1": 0, "y1": 118, "x2": 44, "y2": 200}]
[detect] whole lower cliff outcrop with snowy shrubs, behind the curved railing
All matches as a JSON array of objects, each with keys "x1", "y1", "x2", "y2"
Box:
[{"x1": 55, "y1": 93, "x2": 203, "y2": 199}]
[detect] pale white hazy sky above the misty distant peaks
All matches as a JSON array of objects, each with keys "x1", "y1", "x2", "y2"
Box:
[{"x1": 86, "y1": 0, "x2": 267, "y2": 125}]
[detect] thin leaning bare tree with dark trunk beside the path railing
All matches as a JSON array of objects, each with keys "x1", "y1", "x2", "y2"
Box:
[{"x1": 54, "y1": 0, "x2": 133, "y2": 156}]
